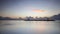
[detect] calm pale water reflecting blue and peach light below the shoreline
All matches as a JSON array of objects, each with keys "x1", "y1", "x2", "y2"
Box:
[{"x1": 0, "y1": 20, "x2": 60, "y2": 34}]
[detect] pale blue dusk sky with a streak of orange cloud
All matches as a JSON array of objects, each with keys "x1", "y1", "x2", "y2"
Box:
[{"x1": 0, "y1": 0, "x2": 60, "y2": 18}]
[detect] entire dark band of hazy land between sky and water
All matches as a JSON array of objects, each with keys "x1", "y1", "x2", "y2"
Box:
[{"x1": 0, "y1": 14, "x2": 60, "y2": 21}]
